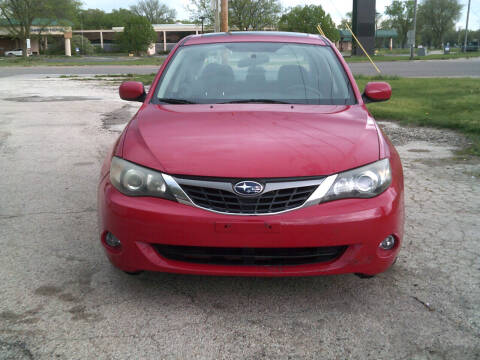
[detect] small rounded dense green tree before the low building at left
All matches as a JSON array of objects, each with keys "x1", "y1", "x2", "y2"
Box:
[{"x1": 119, "y1": 16, "x2": 157, "y2": 55}]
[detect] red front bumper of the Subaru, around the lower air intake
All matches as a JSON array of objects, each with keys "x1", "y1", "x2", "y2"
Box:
[{"x1": 98, "y1": 176, "x2": 404, "y2": 276}]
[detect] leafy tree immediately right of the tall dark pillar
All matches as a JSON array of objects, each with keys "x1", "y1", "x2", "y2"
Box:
[{"x1": 382, "y1": 0, "x2": 415, "y2": 48}]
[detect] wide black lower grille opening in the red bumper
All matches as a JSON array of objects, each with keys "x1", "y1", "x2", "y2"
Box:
[{"x1": 152, "y1": 244, "x2": 347, "y2": 265}]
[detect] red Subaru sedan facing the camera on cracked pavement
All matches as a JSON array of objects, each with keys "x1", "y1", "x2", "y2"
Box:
[{"x1": 98, "y1": 32, "x2": 404, "y2": 277}]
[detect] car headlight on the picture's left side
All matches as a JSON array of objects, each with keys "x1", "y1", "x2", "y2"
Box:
[{"x1": 110, "y1": 157, "x2": 175, "y2": 200}]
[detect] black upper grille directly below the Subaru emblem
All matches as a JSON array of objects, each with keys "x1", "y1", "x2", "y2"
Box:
[{"x1": 181, "y1": 185, "x2": 318, "y2": 214}]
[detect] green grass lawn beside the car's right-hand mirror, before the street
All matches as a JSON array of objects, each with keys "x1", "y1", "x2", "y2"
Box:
[{"x1": 356, "y1": 76, "x2": 480, "y2": 155}]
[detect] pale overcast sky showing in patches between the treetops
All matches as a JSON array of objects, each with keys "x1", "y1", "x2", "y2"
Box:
[{"x1": 83, "y1": 0, "x2": 480, "y2": 30}]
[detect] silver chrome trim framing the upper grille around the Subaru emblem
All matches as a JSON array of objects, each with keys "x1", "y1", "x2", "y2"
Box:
[{"x1": 163, "y1": 174, "x2": 337, "y2": 216}]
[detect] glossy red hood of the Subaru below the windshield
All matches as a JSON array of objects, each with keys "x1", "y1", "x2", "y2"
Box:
[{"x1": 122, "y1": 104, "x2": 379, "y2": 178}]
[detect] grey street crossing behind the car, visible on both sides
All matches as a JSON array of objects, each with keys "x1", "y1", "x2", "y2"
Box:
[{"x1": 0, "y1": 57, "x2": 480, "y2": 78}]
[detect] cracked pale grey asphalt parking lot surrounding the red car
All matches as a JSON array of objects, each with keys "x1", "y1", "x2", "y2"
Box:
[{"x1": 0, "y1": 75, "x2": 480, "y2": 359}]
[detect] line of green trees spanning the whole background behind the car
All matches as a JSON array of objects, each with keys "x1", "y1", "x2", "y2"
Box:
[{"x1": 0, "y1": 0, "x2": 478, "y2": 57}]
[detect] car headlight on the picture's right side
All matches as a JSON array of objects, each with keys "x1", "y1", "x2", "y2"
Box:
[{"x1": 321, "y1": 159, "x2": 392, "y2": 202}]
